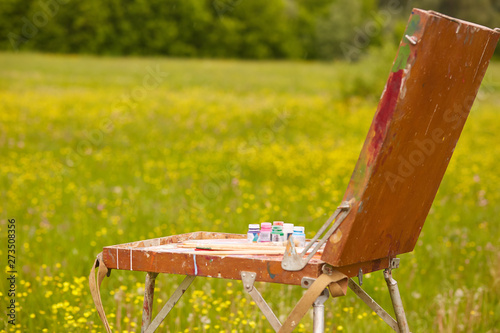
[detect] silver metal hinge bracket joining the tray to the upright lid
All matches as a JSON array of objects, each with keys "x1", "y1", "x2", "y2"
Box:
[{"x1": 281, "y1": 201, "x2": 351, "y2": 271}]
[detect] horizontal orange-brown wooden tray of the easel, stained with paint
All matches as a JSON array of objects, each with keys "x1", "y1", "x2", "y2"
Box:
[{"x1": 103, "y1": 231, "x2": 389, "y2": 285}]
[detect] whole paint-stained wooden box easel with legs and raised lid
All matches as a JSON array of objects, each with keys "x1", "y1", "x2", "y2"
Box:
[{"x1": 90, "y1": 9, "x2": 500, "y2": 333}]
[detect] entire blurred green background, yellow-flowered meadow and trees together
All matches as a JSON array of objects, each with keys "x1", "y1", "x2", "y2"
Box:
[{"x1": 0, "y1": 0, "x2": 500, "y2": 333}]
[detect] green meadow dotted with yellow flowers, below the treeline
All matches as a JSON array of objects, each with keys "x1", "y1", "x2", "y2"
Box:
[{"x1": 0, "y1": 52, "x2": 500, "y2": 332}]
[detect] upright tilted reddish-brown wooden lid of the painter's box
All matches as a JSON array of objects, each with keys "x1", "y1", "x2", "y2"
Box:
[{"x1": 322, "y1": 9, "x2": 500, "y2": 266}]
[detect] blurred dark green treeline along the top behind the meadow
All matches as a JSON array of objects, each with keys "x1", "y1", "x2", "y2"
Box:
[{"x1": 0, "y1": 0, "x2": 500, "y2": 60}]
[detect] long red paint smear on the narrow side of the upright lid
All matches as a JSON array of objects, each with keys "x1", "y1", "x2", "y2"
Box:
[{"x1": 367, "y1": 69, "x2": 403, "y2": 166}]
